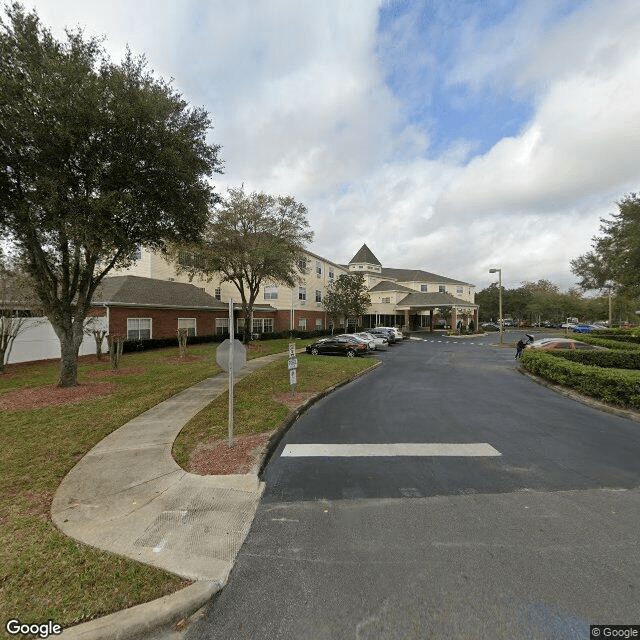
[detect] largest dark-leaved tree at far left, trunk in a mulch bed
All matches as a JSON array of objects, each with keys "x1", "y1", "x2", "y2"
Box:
[{"x1": 0, "y1": 3, "x2": 221, "y2": 387}]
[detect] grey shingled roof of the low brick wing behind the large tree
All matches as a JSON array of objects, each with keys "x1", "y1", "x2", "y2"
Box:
[{"x1": 93, "y1": 276, "x2": 228, "y2": 309}]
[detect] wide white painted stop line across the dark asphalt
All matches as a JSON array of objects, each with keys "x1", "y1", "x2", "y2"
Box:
[{"x1": 282, "y1": 442, "x2": 502, "y2": 458}]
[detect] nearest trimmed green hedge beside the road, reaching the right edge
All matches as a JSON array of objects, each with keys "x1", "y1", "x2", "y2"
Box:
[{"x1": 522, "y1": 349, "x2": 640, "y2": 409}]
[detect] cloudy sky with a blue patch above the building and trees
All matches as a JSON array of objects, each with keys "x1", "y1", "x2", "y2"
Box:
[{"x1": 17, "y1": 0, "x2": 640, "y2": 289}]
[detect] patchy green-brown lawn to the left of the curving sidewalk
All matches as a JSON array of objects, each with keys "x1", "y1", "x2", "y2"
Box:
[{"x1": 0, "y1": 340, "x2": 316, "y2": 637}]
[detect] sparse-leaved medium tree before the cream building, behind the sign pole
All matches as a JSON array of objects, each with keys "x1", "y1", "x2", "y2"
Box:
[{"x1": 168, "y1": 186, "x2": 313, "y2": 342}]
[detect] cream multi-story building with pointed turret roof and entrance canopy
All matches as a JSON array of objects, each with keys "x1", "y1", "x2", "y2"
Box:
[{"x1": 113, "y1": 244, "x2": 478, "y2": 333}]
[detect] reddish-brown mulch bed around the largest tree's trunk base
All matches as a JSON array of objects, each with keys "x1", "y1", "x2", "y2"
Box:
[{"x1": 0, "y1": 382, "x2": 118, "y2": 411}]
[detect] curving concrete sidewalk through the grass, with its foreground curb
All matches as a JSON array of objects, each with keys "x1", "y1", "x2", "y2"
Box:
[{"x1": 51, "y1": 353, "x2": 286, "y2": 640}]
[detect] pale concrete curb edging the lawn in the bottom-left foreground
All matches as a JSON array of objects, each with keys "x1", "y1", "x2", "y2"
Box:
[{"x1": 57, "y1": 582, "x2": 224, "y2": 640}]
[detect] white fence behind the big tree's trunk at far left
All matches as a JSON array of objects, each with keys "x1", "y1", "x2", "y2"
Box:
[{"x1": 6, "y1": 318, "x2": 108, "y2": 364}]
